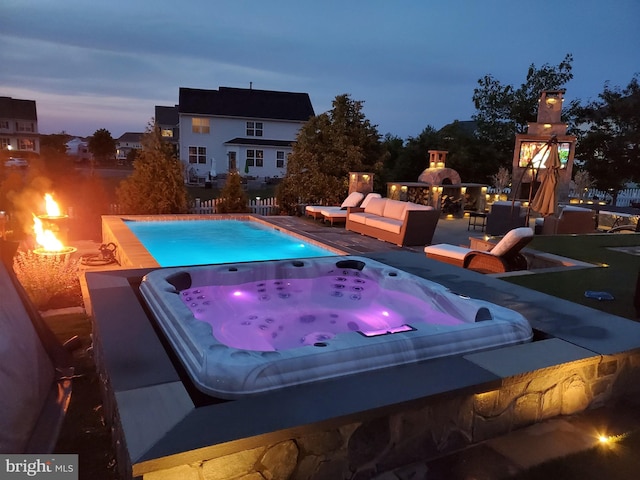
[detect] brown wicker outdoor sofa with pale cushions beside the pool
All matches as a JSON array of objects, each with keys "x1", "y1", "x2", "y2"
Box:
[{"x1": 345, "y1": 198, "x2": 440, "y2": 246}]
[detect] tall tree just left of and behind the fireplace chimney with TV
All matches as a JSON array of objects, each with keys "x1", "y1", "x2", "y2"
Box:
[{"x1": 472, "y1": 54, "x2": 579, "y2": 167}]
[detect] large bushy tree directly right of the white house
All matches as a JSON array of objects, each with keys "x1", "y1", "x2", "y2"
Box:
[{"x1": 276, "y1": 94, "x2": 386, "y2": 213}]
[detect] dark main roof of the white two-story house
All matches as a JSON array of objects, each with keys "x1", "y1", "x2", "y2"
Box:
[{"x1": 179, "y1": 87, "x2": 315, "y2": 122}]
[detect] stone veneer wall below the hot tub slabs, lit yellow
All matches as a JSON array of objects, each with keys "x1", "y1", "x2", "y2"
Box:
[{"x1": 144, "y1": 352, "x2": 640, "y2": 480}]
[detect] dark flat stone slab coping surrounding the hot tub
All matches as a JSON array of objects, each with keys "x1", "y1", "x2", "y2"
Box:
[{"x1": 86, "y1": 251, "x2": 640, "y2": 475}]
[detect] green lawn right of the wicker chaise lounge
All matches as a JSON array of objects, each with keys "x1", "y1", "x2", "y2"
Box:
[{"x1": 504, "y1": 233, "x2": 640, "y2": 320}]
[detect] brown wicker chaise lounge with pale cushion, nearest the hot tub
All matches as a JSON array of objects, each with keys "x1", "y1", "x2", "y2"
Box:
[{"x1": 424, "y1": 227, "x2": 533, "y2": 273}]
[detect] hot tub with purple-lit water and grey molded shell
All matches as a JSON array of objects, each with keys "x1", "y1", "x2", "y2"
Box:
[{"x1": 140, "y1": 256, "x2": 533, "y2": 399}]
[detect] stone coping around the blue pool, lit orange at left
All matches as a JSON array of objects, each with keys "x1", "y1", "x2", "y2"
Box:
[{"x1": 102, "y1": 213, "x2": 348, "y2": 268}]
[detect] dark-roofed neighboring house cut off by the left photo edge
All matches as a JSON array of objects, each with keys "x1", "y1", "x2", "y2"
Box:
[{"x1": 0, "y1": 97, "x2": 40, "y2": 154}]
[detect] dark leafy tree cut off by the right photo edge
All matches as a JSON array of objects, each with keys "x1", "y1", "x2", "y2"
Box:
[{"x1": 576, "y1": 74, "x2": 640, "y2": 196}]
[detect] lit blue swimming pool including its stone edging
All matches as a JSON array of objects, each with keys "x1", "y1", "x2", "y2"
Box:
[{"x1": 102, "y1": 215, "x2": 345, "y2": 267}]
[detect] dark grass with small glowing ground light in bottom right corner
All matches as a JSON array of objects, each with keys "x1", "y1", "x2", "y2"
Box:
[{"x1": 509, "y1": 431, "x2": 640, "y2": 480}]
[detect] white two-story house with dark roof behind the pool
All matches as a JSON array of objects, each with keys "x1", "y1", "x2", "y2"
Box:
[{"x1": 178, "y1": 87, "x2": 314, "y2": 183}]
